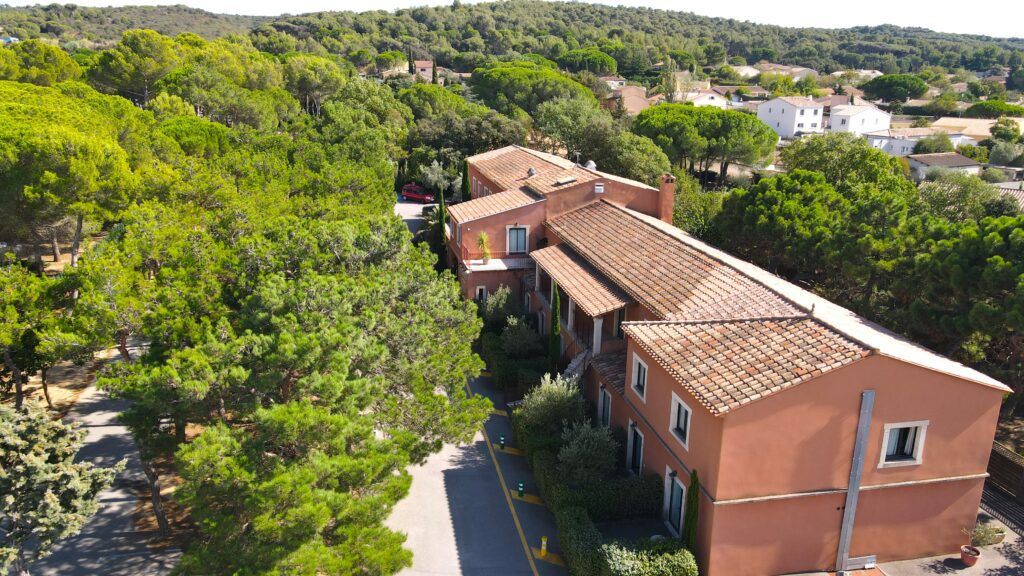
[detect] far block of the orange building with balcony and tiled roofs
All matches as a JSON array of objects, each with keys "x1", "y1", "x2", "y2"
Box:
[{"x1": 446, "y1": 146, "x2": 675, "y2": 299}]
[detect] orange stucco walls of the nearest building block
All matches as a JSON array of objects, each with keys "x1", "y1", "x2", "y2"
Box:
[{"x1": 587, "y1": 338, "x2": 1001, "y2": 576}]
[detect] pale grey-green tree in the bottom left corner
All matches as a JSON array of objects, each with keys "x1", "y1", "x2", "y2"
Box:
[{"x1": 0, "y1": 403, "x2": 123, "y2": 576}]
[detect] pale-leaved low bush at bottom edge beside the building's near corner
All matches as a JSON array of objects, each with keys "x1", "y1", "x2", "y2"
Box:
[{"x1": 600, "y1": 538, "x2": 697, "y2": 576}]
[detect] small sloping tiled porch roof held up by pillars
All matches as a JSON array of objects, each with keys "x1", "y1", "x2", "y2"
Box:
[{"x1": 529, "y1": 244, "x2": 633, "y2": 317}]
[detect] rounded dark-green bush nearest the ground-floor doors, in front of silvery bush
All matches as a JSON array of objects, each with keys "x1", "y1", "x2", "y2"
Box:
[{"x1": 558, "y1": 420, "x2": 618, "y2": 487}]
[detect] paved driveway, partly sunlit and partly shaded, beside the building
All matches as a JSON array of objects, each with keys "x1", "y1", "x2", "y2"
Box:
[{"x1": 387, "y1": 377, "x2": 566, "y2": 576}]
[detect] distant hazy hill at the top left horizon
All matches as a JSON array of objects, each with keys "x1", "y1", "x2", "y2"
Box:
[{"x1": 0, "y1": 4, "x2": 268, "y2": 47}]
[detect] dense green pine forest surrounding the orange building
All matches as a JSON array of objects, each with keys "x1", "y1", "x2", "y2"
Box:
[{"x1": 0, "y1": 1, "x2": 1024, "y2": 574}]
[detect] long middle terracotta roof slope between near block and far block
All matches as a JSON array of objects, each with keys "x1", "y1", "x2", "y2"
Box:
[{"x1": 547, "y1": 202, "x2": 802, "y2": 321}]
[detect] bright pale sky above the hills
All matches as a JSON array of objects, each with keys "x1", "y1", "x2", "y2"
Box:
[{"x1": 8, "y1": 0, "x2": 1024, "y2": 38}]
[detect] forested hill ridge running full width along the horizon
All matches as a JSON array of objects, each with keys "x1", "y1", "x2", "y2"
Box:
[{"x1": 6, "y1": 0, "x2": 1024, "y2": 75}]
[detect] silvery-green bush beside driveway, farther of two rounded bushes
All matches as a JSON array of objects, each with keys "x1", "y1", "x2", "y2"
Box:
[{"x1": 512, "y1": 374, "x2": 584, "y2": 452}]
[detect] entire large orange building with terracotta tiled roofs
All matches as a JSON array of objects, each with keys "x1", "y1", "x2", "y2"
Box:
[{"x1": 452, "y1": 147, "x2": 1010, "y2": 576}]
